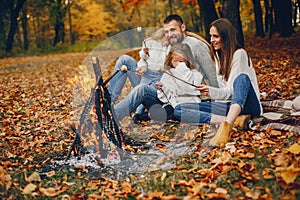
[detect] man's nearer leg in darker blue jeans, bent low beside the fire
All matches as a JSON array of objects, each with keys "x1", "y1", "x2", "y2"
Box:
[{"x1": 114, "y1": 84, "x2": 162, "y2": 120}]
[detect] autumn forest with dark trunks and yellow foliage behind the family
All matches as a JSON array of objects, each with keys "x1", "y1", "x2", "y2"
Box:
[{"x1": 0, "y1": 0, "x2": 299, "y2": 57}]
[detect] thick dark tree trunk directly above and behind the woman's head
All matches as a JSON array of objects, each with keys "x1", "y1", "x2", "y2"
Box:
[{"x1": 222, "y1": 0, "x2": 244, "y2": 46}]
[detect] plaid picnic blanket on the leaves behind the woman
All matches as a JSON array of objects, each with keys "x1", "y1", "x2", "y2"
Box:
[{"x1": 249, "y1": 89, "x2": 300, "y2": 133}]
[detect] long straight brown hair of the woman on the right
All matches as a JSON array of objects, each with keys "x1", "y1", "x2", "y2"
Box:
[{"x1": 209, "y1": 18, "x2": 242, "y2": 81}]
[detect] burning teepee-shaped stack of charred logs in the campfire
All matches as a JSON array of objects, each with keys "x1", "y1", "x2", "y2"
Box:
[{"x1": 66, "y1": 57, "x2": 127, "y2": 160}]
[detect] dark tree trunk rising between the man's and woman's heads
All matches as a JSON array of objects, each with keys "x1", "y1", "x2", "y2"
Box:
[{"x1": 198, "y1": 0, "x2": 218, "y2": 41}]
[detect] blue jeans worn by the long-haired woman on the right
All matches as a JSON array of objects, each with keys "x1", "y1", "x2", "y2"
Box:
[{"x1": 174, "y1": 74, "x2": 261, "y2": 124}]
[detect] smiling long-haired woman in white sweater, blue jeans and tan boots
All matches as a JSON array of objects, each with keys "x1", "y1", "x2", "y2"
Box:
[{"x1": 174, "y1": 18, "x2": 262, "y2": 146}]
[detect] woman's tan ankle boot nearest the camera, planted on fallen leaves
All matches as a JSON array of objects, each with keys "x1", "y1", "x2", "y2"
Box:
[{"x1": 209, "y1": 121, "x2": 232, "y2": 147}]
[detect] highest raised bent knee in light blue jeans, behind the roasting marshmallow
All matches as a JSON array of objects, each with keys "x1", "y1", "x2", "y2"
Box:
[{"x1": 107, "y1": 55, "x2": 141, "y2": 103}]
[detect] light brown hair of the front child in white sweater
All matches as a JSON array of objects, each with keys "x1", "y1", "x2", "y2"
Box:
[{"x1": 164, "y1": 43, "x2": 196, "y2": 70}]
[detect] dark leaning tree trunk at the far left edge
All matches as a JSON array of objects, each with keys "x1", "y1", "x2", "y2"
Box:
[{"x1": 5, "y1": 0, "x2": 26, "y2": 53}]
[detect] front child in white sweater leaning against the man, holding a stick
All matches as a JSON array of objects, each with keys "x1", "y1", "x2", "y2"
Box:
[{"x1": 156, "y1": 43, "x2": 203, "y2": 108}]
